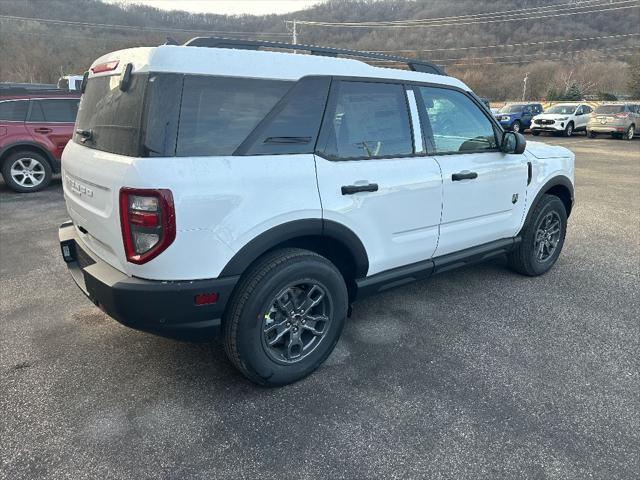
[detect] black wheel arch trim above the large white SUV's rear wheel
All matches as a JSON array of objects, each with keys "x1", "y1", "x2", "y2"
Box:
[{"x1": 219, "y1": 218, "x2": 369, "y2": 278}]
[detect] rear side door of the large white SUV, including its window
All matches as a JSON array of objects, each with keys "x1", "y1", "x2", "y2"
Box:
[{"x1": 316, "y1": 80, "x2": 442, "y2": 275}]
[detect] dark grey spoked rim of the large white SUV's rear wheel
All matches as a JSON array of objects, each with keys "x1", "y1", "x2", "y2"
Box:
[{"x1": 262, "y1": 281, "x2": 333, "y2": 364}]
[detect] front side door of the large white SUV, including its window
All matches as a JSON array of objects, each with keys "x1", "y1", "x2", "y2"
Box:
[{"x1": 418, "y1": 87, "x2": 528, "y2": 256}]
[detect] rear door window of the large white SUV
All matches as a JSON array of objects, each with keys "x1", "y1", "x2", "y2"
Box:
[{"x1": 323, "y1": 81, "x2": 413, "y2": 159}]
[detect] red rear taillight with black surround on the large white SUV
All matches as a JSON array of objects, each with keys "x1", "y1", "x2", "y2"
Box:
[{"x1": 120, "y1": 188, "x2": 176, "y2": 265}]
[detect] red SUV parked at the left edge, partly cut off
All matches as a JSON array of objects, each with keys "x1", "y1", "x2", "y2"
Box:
[{"x1": 0, "y1": 89, "x2": 80, "y2": 192}]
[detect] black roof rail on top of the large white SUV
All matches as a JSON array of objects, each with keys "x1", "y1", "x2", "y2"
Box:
[{"x1": 184, "y1": 37, "x2": 447, "y2": 76}]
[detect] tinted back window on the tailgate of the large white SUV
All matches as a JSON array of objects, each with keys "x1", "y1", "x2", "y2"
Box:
[{"x1": 74, "y1": 75, "x2": 148, "y2": 156}]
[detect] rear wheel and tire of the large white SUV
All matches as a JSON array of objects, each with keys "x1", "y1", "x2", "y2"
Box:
[{"x1": 223, "y1": 248, "x2": 349, "y2": 387}]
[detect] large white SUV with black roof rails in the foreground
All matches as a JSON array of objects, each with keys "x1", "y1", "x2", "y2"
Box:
[{"x1": 59, "y1": 38, "x2": 574, "y2": 385}]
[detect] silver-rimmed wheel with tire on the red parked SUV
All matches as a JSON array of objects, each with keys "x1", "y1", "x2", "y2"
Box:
[{"x1": 2, "y1": 150, "x2": 53, "y2": 193}]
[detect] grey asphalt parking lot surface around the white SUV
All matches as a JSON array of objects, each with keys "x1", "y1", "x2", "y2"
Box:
[{"x1": 0, "y1": 135, "x2": 640, "y2": 480}]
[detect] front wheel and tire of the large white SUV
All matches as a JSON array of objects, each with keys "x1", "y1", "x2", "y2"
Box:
[{"x1": 509, "y1": 195, "x2": 567, "y2": 277}]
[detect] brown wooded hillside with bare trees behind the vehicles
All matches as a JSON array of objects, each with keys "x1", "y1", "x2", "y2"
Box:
[{"x1": 0, "y1": 0, "x2": 640, "y2": 100}]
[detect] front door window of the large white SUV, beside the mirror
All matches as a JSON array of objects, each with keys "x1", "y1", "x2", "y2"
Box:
[{"x1": 419, "y1": 87, "x2": 498, "y2": 154}]
